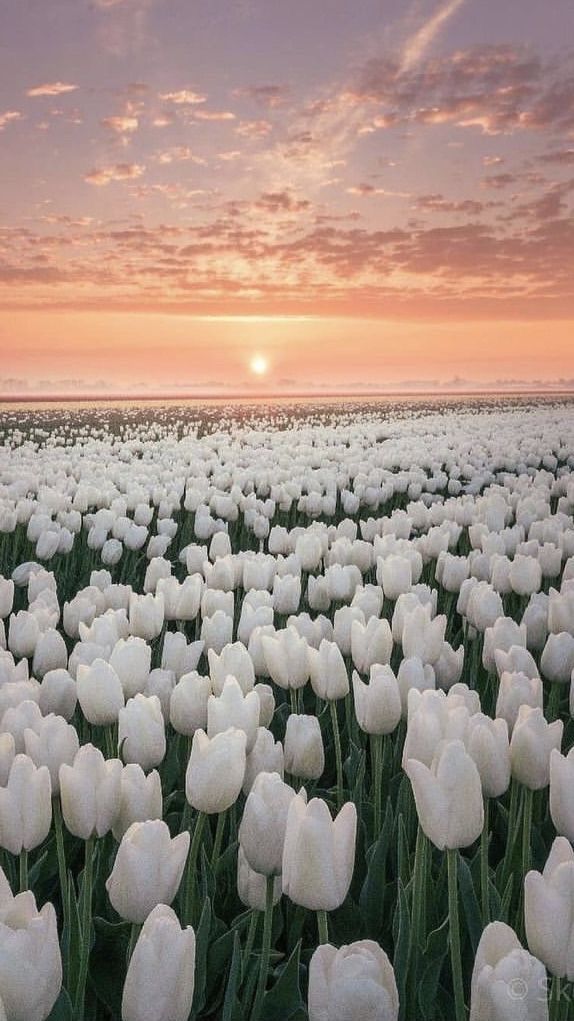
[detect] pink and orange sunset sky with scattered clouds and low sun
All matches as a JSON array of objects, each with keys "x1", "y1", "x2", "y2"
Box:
[{"x1": 0, "y1": 0, "x2": 574, "y2": 394}]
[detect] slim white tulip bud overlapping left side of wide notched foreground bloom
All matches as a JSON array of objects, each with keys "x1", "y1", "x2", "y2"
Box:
[{"x1": 239, "y1": 773, "x2": 296, "y2": 876}]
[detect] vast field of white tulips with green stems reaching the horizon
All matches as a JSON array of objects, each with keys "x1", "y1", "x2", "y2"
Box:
[{"x1": 0, "y1": 397, "x2": 574, "y2": 1021}]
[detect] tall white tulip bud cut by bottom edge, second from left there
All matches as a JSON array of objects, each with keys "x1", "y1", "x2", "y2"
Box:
[{"x1": 122, "y1": 904, "x2": 195, "y2": 1021}]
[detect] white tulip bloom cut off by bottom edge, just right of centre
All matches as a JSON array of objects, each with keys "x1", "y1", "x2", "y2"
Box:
[{"x1": 308, "y1": 939, "x2": 398, "y2": 1021}]
